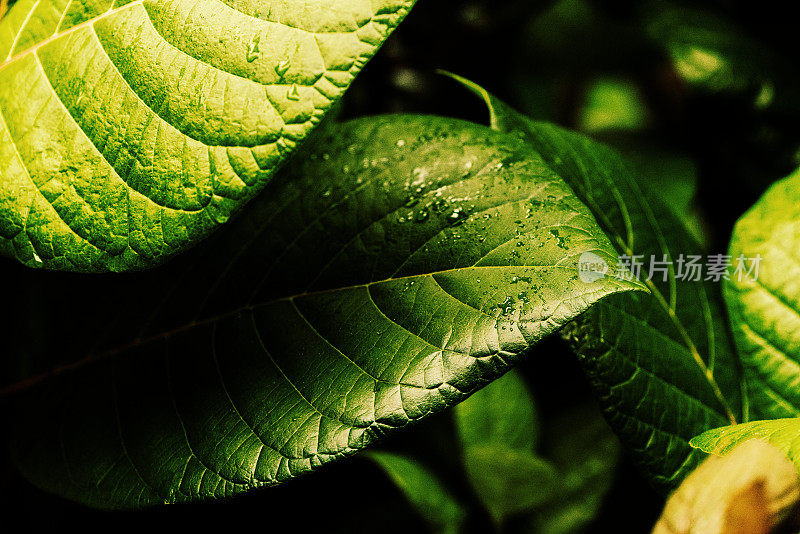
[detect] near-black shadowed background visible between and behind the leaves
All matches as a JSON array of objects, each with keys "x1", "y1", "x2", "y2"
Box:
[{"x1": 0, "y1": 0, "x2": 800, "y2": 533}]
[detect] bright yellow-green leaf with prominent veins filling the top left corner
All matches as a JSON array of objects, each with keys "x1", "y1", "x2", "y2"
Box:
[{"x1": 0, "y1": 0, "x2": 414, "y2": 271}]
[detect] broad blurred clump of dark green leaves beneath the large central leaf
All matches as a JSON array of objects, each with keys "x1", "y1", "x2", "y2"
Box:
[{"x1": 453, "y1": 371, "x2": 619, "y2": 534}]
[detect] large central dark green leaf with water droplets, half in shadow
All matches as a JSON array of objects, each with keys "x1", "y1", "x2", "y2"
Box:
[{"x1": 0, "y1": 116, "x2": 643, "y2": 508}]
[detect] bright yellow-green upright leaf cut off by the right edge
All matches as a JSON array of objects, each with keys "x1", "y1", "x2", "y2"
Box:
[{"x1": 725, "y1": 170, "x2": 800, "y2": 419}]
